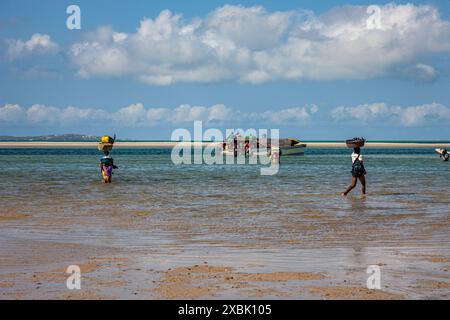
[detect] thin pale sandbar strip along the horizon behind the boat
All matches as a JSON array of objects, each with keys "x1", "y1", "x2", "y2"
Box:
[{"x1": 0, "y1": 141, "x2": 450, "y2": 149}]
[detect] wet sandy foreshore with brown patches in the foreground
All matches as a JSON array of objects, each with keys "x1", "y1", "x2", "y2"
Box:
[{"x1": 0, "y1": 208, "x2": 450, "y2": 300}]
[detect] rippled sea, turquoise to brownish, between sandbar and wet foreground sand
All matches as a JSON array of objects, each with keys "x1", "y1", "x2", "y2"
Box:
[{"x1": 0, "y1": 148, "x2": 450, "y2": 246}]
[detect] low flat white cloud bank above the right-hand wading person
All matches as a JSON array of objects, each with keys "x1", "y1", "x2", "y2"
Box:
[{"x1": 331, "y1": 103, "x2": 450, "y2": 127}]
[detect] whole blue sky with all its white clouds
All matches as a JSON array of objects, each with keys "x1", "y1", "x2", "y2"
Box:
[{"x1": 0, "y1": 0, "x2": 450, "y2": 140}]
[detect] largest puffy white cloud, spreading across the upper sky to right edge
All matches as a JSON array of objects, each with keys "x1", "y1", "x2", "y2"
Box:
[{"x1": 70, "y1": 4, "x2": 450, "y2": 85}]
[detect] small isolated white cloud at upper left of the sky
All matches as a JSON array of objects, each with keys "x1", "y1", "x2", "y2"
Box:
[{"x1": 7, "y1": 33, "x2": 58, "y2": 59}]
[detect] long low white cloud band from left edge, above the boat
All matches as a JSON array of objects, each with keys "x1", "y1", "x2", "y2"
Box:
[{"x1": 0, "y1": 103, "x2": 318, "y2": 127}]
